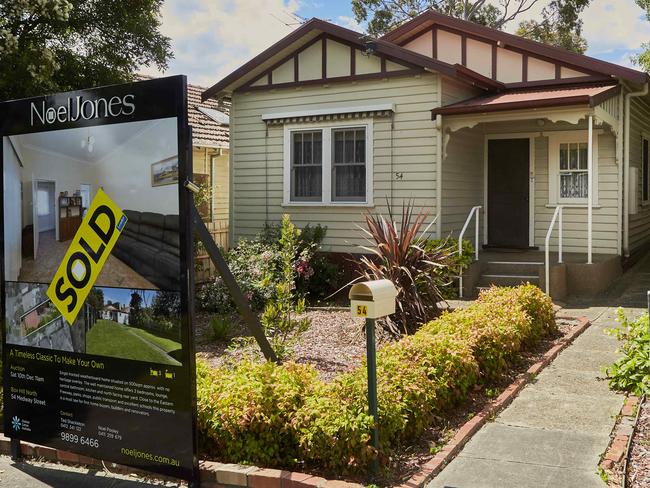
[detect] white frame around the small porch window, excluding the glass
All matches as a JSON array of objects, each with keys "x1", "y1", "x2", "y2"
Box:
[{"x1": 547, "y1": 129, "x2": 603, "y2": 207}]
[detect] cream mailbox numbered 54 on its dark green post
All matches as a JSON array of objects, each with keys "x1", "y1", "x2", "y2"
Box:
[{"x1": 349, "y1": 280, "x2": 397, "y2": 475}]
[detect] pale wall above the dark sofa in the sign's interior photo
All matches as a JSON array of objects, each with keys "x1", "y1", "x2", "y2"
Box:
[{"x1": 93, "y1": 119, "x2": 178, "y2": 214}]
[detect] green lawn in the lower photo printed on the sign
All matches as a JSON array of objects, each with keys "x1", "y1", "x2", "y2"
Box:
[{"x1": 86, "y1": 320, "x2": 180, "y2": 366}]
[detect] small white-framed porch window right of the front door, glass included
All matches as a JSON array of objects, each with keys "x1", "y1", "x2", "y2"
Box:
[{"x1": 548, "y1": 129, "x2": 602, "y2": 206}]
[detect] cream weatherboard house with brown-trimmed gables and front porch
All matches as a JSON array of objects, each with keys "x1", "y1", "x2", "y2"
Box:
[{"x1": 203, "y1": 11, "x2": 650, "y2": 297}]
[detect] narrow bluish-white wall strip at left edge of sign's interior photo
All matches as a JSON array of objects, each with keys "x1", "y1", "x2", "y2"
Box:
[{"x1": 2, "y1": 137, "x2": 23, "y2": 281}]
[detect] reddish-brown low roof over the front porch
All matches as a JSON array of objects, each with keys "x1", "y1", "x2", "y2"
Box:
[{"x1": 431, "y1": 84, "x2": 620, "y2": 118}]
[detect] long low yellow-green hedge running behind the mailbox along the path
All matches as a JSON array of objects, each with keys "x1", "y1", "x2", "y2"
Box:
[{"x1": 197, "y1": 285, "x2": 557, "y2": 473}]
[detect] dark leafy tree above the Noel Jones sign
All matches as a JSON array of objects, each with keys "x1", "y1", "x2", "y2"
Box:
[{"x1": 0, "y1": 0, "x2": 172, "y2": 99}]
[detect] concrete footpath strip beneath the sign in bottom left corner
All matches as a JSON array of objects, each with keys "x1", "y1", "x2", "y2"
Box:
[{"x1": 0, "y1": 456, "x2": 181, "y2": 488}]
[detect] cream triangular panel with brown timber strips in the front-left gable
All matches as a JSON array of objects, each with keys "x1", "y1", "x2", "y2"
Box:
[{"x1": 236, "y1": 33, "x2": 424, "y2": 91}]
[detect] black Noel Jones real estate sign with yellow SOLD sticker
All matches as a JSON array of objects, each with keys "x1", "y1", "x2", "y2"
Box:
[{"x1": 0, "y1": 76, "x2": 197, "y2": 480}]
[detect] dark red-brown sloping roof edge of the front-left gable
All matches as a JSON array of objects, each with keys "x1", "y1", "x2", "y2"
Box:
[{"x1": 202, "y1": 18, "x2": 502, "y2": 100}]
